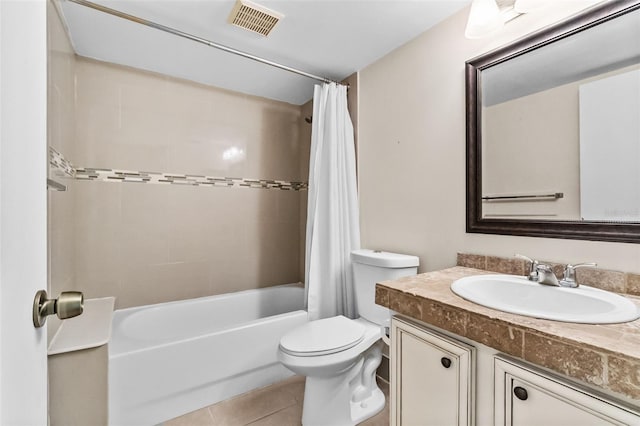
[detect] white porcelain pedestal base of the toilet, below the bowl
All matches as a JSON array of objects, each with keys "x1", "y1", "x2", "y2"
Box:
[{"x1": 302, "y1": 340, "x2": 385, "y2": 426}]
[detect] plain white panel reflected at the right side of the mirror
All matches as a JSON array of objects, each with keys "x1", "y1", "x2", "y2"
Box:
[{"x1": 580, "y1": 70, "x2": 640, "y2": 222}]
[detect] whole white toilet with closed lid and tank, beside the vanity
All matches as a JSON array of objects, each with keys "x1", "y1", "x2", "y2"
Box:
[{"x1": 278, "y1": 249, "x2": 419, "y2": 426}]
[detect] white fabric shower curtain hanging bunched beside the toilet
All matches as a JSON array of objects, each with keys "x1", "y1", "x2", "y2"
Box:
[{"x1": 305, "y1": 83, "x2": 360, "y2": 320}]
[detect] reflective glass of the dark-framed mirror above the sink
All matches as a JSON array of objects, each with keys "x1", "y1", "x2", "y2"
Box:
[{"x1": 478, "y1": 6, "x2": 640, "y2": 223}]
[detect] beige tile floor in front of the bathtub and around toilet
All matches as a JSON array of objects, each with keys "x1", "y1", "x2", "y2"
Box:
[{"x1": 163, "y1": 376, "x2": 389, "y2": 426}]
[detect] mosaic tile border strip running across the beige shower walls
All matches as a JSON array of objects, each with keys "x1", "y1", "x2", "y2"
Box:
[{"x1": 49, "y1": 148, "x2": 308, "y2": 191}]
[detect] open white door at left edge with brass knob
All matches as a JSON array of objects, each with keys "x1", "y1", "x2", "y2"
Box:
[{"x1": 0, "y1": 0, "x2": 47, "y2": 425}]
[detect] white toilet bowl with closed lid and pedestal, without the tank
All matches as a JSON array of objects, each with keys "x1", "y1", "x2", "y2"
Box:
[{"x1": 278, "y1": 316, "x2": 385, "y2": 426}]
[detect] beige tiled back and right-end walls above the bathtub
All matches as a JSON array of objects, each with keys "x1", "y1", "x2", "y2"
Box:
[{"x1": 71, "y1": 58, "x2": 304, "y2": 308}]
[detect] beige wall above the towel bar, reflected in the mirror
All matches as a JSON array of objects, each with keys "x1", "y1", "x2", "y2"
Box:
[{"x1": 482, "y1": 83, "x2": 580, "y2": 220}]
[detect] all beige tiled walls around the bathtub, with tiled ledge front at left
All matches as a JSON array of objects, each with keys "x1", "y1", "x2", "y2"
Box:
[{"x1": 48, "y1": 1, "x2": 310, "y2": 425}]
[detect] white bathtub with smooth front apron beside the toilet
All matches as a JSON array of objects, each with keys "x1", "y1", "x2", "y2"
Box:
[{"x1": 109, "y1": 285, "x2": 307, "y2": 425}]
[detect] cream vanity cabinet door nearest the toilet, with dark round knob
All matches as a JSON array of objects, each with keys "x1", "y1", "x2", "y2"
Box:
[{"x1": 391, "y1": 318, "x2": 474, "y2": 426}]
